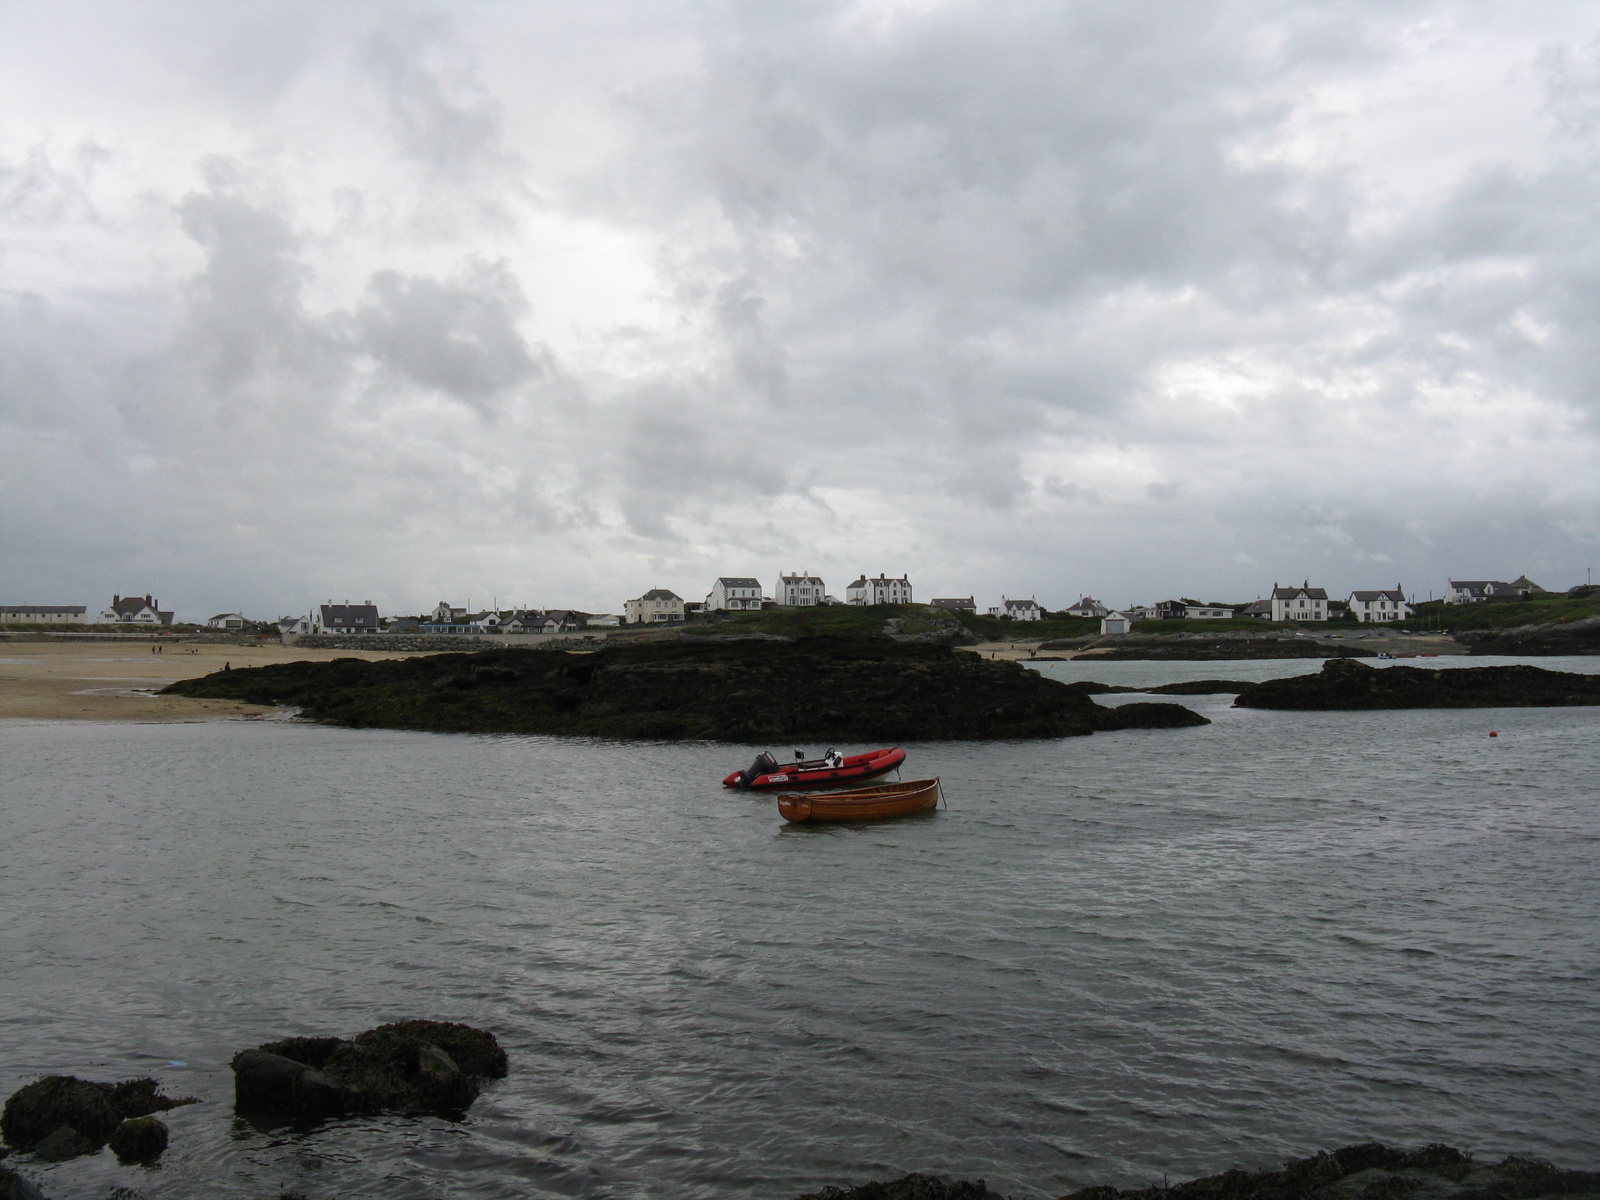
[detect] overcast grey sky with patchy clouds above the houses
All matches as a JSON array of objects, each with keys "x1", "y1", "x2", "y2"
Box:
[{"x1": 0, "y1": 0, "x2": 1600, "y2": 618}]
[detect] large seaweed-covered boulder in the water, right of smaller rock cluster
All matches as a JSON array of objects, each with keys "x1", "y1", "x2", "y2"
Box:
[{"x1": 232, "y1": 1021, "x2": 506, "y2": 1120}]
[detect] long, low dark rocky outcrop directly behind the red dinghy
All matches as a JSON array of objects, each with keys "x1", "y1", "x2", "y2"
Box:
[{"x1": 166, "y1": 638, "x2": 1205, "y2": 744}]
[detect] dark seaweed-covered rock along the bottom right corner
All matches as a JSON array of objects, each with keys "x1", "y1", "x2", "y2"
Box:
[{"x1": 1064, "y1": 1142, "x2": 1600, "y2": 1200}]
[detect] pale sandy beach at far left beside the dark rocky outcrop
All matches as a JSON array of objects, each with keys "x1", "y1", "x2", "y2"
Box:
[{"x1": 0, "y1": 642, "x2": 432, "y2": 722}]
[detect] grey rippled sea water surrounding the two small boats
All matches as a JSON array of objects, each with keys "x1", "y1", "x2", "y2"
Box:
[{"x1": 0, "y1": 659, "x2": 1600, "y2": 1200}]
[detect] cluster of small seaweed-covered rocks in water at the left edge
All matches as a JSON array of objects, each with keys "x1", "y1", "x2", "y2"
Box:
[{"x1": 0, "y1": 1075, "x2": 197, "y2": 1162}]
